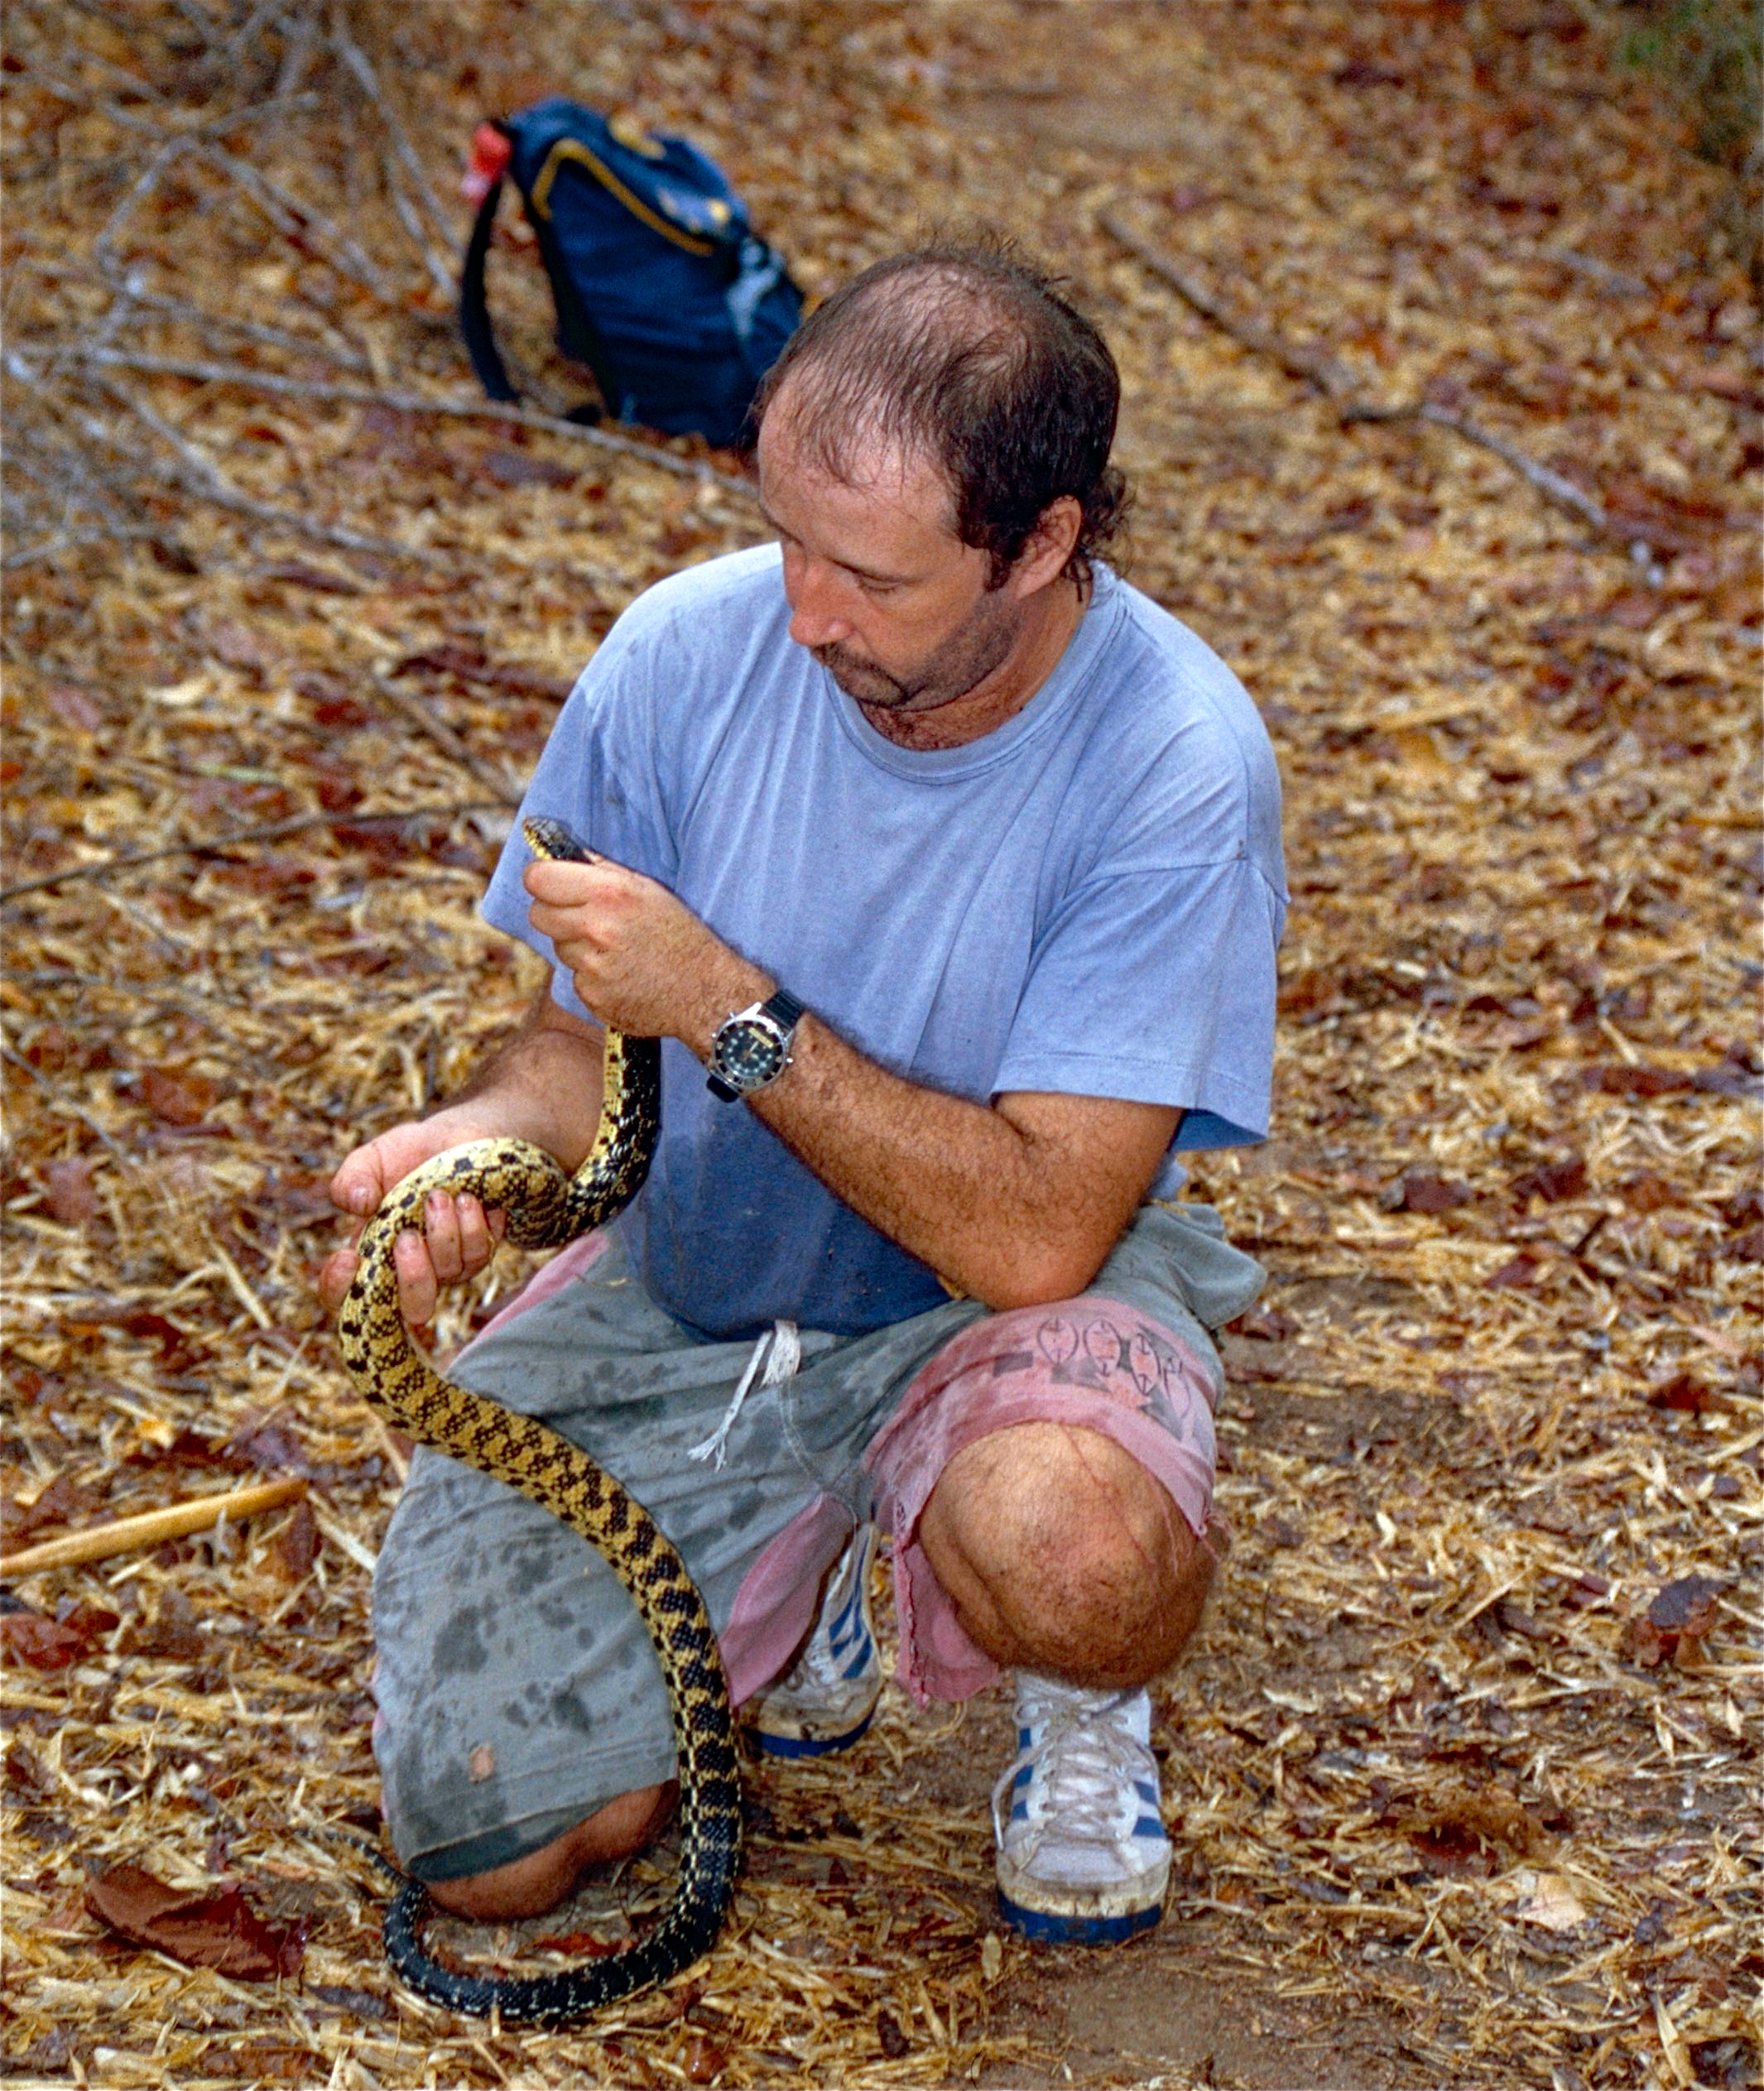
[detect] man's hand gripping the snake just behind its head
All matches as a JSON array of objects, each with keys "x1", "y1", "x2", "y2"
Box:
[{"x1": 525, "y1": 858, "x2": 773, "y2": 1060}]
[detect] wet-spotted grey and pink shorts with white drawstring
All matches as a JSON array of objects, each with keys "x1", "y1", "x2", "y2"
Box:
[{"x1": 374, "y1": 1204, "x2": 1262, "y2": 1880}]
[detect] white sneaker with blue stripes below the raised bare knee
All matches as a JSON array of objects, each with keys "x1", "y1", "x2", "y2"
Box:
[{"x1": 993, "y1": 1670, "x2": 1170, "y2": 1944}]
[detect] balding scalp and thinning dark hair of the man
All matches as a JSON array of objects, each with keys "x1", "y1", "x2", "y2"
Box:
[{"x1": 754, "y1": 243, "x2": 1127, "y2": 584}]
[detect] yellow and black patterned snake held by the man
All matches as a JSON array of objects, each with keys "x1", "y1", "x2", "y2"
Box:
[{"x1": 337, "y1": 815, "x2": 742, "y2": 2026}]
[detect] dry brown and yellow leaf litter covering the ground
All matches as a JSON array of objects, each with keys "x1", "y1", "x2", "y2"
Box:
[{"x1": 0, "y1": 0, "x2": 1764, "y2": 2091}]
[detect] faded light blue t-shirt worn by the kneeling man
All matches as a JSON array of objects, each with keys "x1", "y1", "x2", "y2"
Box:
[{"x1": 483, "y1": 546, "x2": 1286, "y2": 1339}]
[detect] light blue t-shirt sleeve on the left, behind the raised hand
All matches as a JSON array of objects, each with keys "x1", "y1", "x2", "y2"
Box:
[{"x1": 483, "y1": 629, "x2": 675, "y2": 1022}]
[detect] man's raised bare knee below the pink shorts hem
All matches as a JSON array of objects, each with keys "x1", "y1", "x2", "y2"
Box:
[{"x1": 920, "y1": 1422, "x2": 1214, "y2": 1685}]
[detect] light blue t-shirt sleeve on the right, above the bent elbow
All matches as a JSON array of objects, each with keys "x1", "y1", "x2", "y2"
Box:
[{"x1": 997, "y1": 858, "x2": 1283, "y2": 1150}]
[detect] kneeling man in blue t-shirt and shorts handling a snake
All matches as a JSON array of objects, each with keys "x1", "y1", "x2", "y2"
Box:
[{"x1": 324, "y1": 247, "x2": 1283, "y2": 1940}]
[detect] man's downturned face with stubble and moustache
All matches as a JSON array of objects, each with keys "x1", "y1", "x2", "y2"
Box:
[{"x1": 759, "y1": 391, "x2": 1024, "y2": 713}]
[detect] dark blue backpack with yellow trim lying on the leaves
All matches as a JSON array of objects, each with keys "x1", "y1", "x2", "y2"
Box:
[{"x1": 459, "y1": 99, "x2": 803, "y2": 445}]
